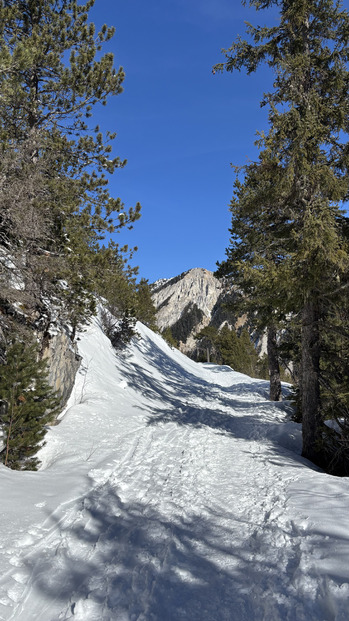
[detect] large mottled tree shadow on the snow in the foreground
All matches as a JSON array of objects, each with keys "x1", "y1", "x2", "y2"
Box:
[{"x1": 24, "y1": 483, "x2": 334, "y2": 621}]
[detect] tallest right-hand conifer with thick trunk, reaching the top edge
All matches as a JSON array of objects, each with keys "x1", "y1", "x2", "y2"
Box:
[{"x1": 217, "y1": 0, "x2": 349, "y2": 466}]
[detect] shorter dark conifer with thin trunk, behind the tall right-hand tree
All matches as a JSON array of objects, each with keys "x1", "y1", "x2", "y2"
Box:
[{"x1": 216, "y1": 152, "x2": 290, "y2": 401}]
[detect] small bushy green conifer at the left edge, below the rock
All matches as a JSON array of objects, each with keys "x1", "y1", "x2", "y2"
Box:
[{"x1": 0, "y1": 341, "x2": 60, "y2": 470}]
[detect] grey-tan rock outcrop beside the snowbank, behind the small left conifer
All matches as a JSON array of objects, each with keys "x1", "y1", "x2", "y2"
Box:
[{"x1": 43, "y1": 328, "x2": 81, "y2": 406}]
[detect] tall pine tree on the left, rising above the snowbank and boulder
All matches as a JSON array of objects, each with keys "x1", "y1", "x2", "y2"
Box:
[{"x1": 0, "y1": 0, "x2": 140, "y2": 324}]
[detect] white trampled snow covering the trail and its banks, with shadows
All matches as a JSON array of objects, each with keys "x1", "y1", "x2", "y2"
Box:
[{"x1": 0, "y1": 320, "x2": 349, "y2": 621}]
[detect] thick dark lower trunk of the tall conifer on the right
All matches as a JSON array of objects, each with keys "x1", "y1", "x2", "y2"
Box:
[{"x1": 300, "y1": 300, "x2": 324, "y2": 465}]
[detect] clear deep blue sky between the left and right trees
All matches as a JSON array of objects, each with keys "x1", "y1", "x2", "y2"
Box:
[{"x1": 91, "y1": 0, "x2": 271, "y2": 282}]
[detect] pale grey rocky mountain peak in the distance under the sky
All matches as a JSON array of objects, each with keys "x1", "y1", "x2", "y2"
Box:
[{"x1": 152, "y1": 268, "x2": 236, "y2": 357}]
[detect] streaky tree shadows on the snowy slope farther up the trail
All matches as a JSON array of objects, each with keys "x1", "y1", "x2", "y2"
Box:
[{"x1": 119, "y1": 332, "x2": 308, "y2": 468}]
